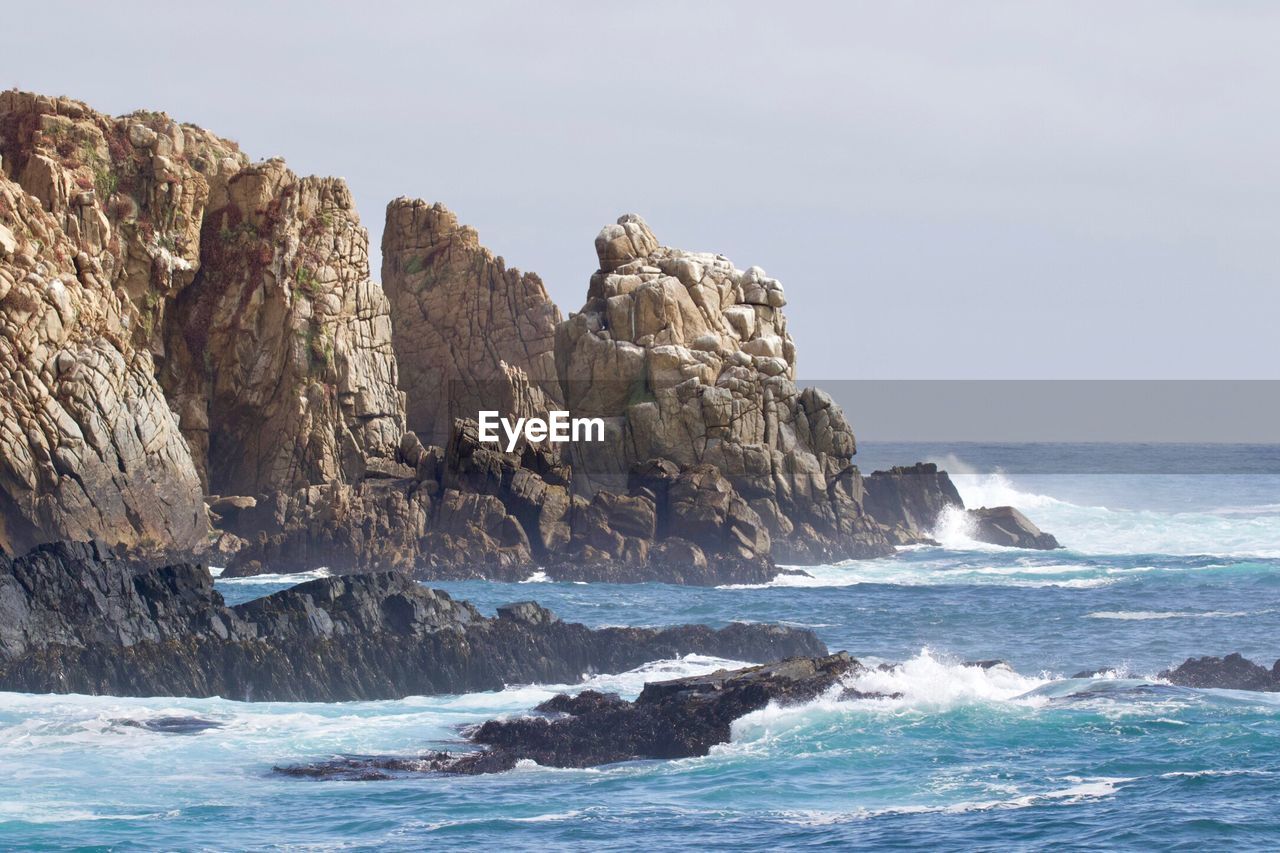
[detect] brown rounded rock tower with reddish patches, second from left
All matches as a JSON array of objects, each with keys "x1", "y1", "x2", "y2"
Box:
[{"x1": 161, "y1": 160, "x2": 404, "y2": 494}]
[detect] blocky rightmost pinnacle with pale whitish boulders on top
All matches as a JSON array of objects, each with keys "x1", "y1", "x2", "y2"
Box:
[{"x1": 556, "y1": 215, "x2": 892, "y2": 558}]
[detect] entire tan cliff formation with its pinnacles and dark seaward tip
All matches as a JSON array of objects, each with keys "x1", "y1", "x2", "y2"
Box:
[{"x1": 0, "y1": 92, "x2": 1056, "y2": 584}]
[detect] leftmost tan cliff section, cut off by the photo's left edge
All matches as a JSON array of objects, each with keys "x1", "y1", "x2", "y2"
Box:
[{"x1": 0, "y1": 92, "x2": 222, "y2": 552}]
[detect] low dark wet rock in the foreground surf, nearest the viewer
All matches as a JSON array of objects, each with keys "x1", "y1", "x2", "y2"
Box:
[{"x1": 276, "y1": 652, "x2": 863, "y2": 780}]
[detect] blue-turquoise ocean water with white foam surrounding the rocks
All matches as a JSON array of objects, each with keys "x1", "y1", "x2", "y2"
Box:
[{"x1": 0, "y1": 444, "x2": 1280, "y2": 849}]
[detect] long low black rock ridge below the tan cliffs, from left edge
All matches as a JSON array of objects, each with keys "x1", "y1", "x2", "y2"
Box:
[{"x1": 0, "y1": 544, "x2": 826, "y2": 702}]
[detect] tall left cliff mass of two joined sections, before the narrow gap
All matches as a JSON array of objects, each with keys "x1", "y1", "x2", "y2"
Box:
[{"x1": 0, "y1": 92, "x2": 404, "y2": 552}]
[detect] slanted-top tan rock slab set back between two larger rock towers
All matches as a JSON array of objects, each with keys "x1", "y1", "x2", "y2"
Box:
[{"x1": 383, "y1": 199, "x2": 561, "y2": 446}]
